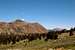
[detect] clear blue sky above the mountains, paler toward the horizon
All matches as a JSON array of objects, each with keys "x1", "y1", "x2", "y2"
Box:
[{"x1": 0, "y1": 0, "x2": 75, "y2": 29}]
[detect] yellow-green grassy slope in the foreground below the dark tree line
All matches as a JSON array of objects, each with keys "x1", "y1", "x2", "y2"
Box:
[{"x1": 0, "y1": 36, "x2": 75, "y2": 50}]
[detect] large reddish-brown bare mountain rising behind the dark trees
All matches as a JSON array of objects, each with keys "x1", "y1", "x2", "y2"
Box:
[{"x1": 0, "y1": 20, "x2": 48, "y2": 34}]
